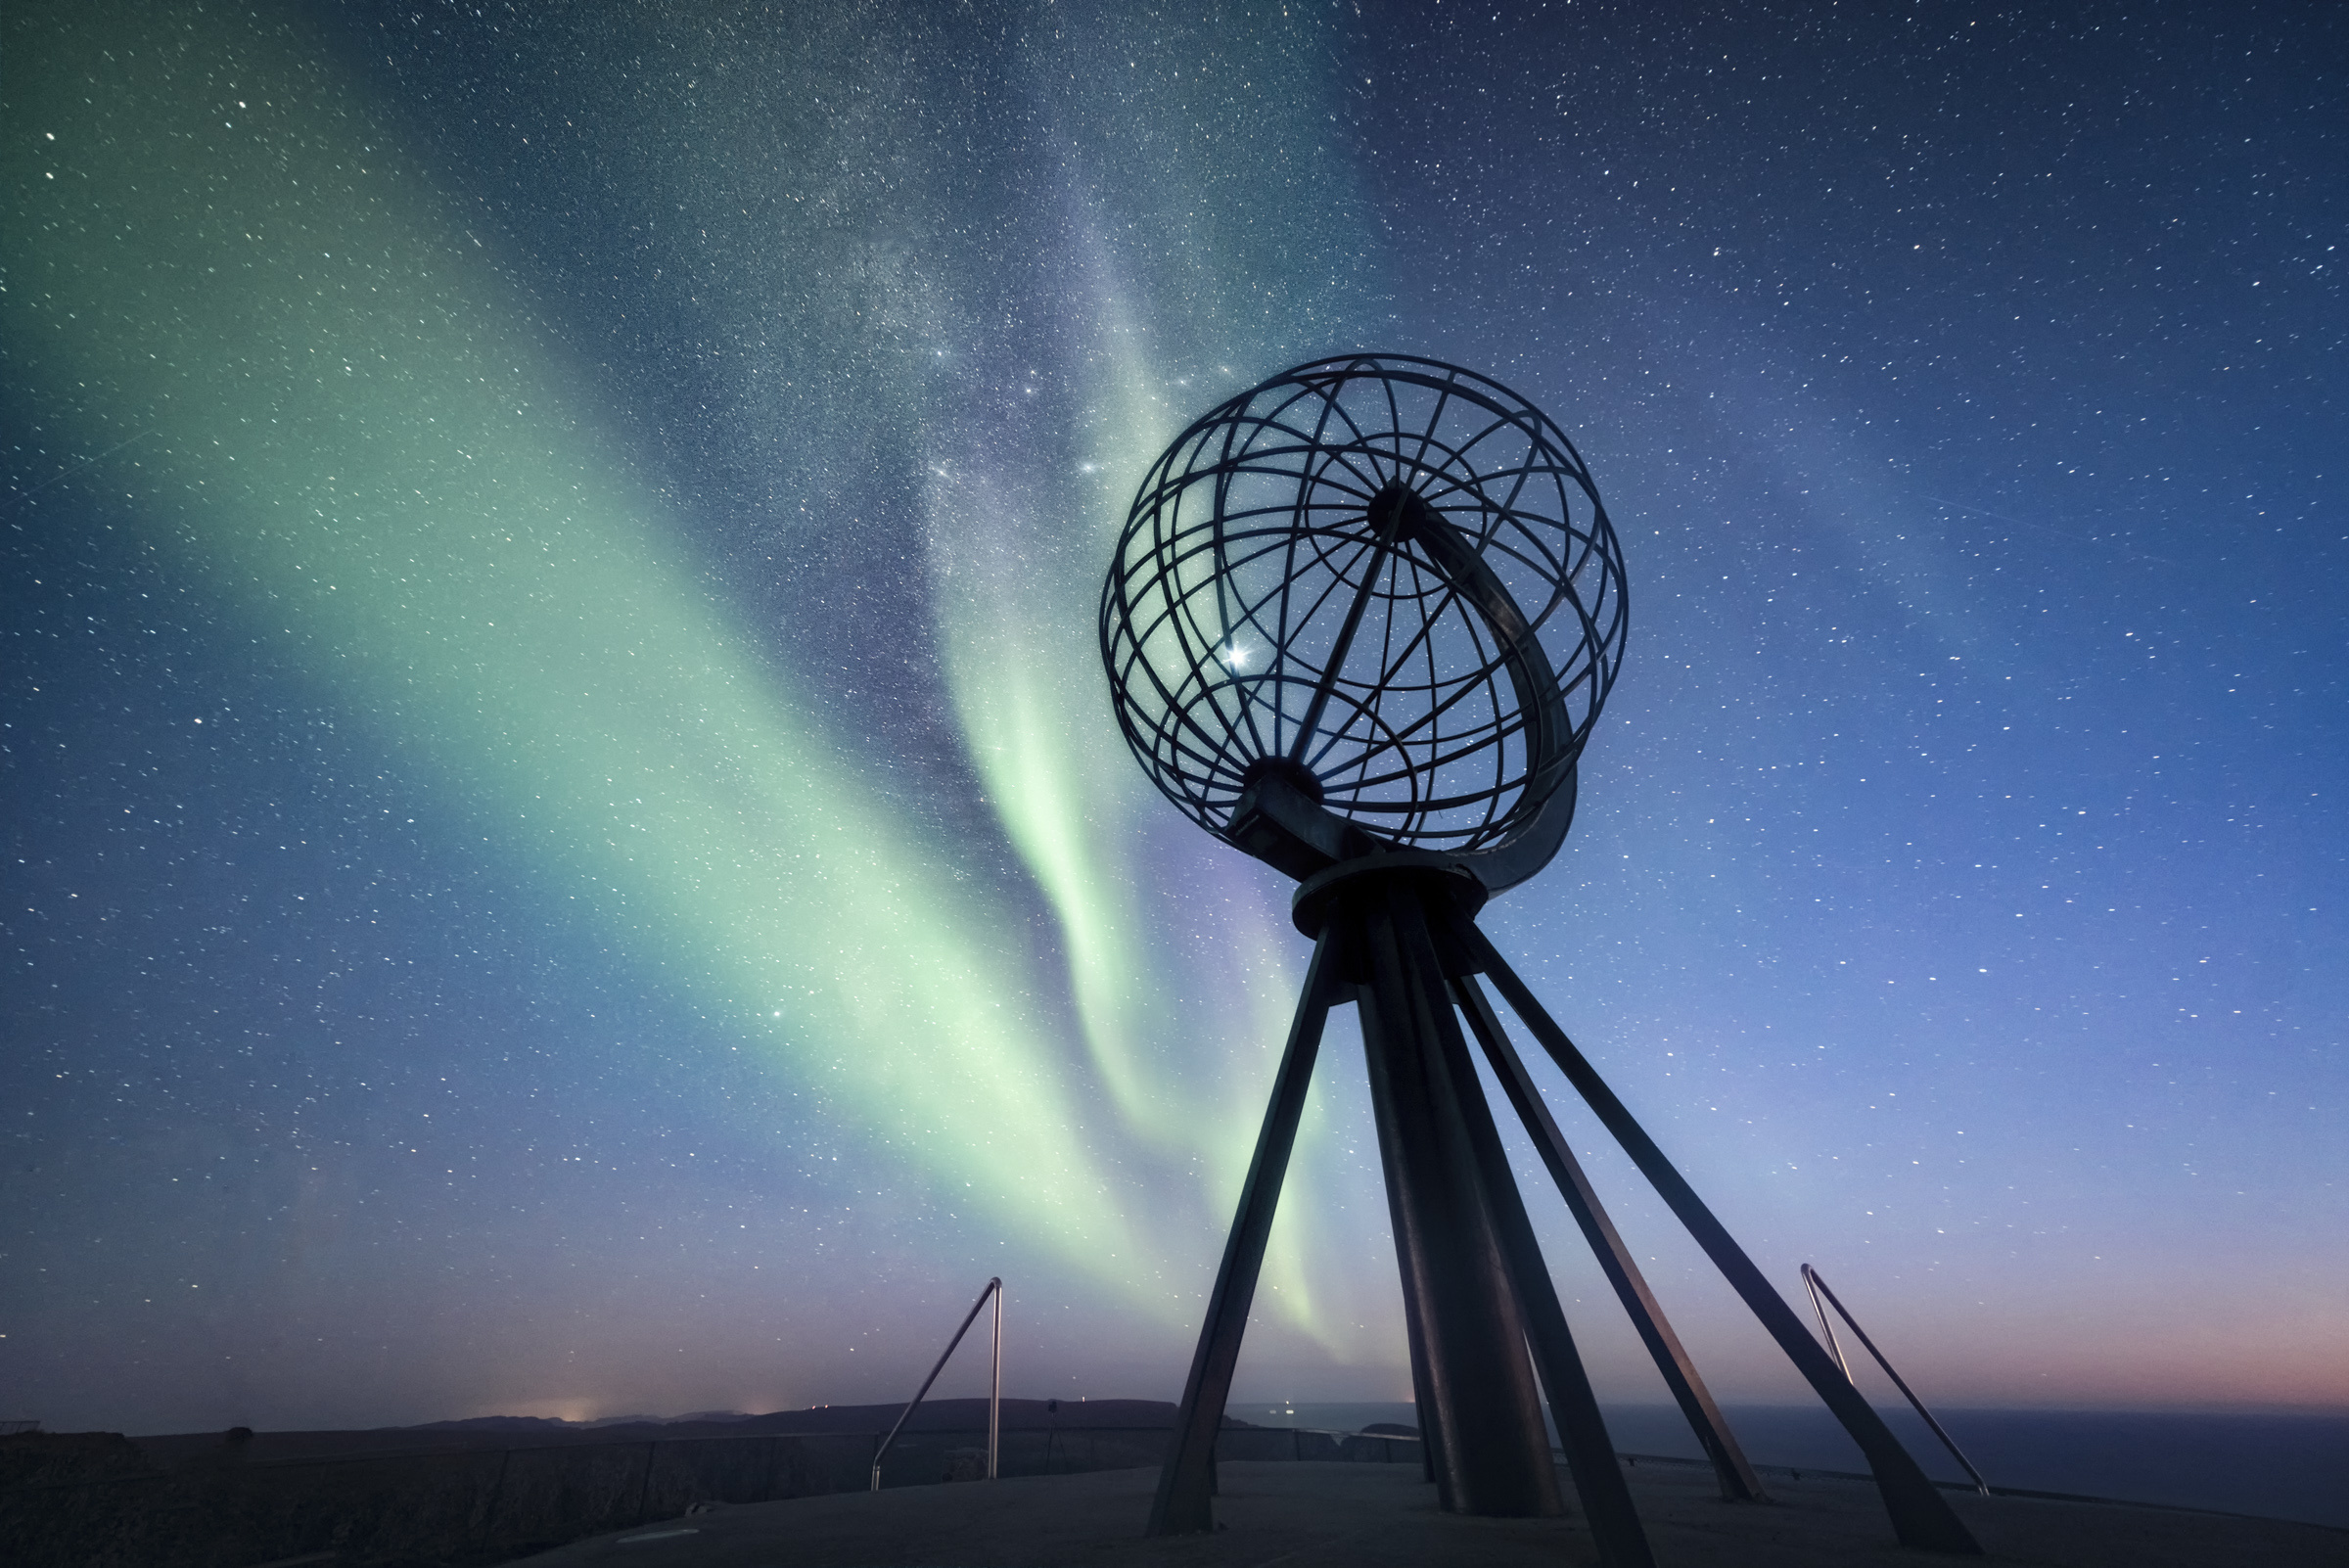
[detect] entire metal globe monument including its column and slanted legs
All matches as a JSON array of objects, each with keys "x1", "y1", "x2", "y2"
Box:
[{"x1": 1118, "y1": 354, "x2": 1980, "y2": 1568}]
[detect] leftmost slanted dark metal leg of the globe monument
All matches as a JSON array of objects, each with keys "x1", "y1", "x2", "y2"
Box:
[{"x1": 1146, "y1": 932, "x2": 1339, "y2": 1535}]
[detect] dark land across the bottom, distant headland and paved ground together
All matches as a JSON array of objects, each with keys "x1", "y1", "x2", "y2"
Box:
[{"x1": 0, "y1": 1399, "x2": 2349, "y2": 1568}]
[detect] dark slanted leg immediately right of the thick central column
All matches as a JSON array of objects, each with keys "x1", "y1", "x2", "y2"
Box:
[{"x1": 1450, "y1": 981, "x2": 1656, "y2": 1568}]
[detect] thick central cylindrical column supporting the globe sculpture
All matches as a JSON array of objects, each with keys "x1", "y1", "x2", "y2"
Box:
[{"x1": 1334, "y1": 878, "x2": 1564, "y2": 1519}]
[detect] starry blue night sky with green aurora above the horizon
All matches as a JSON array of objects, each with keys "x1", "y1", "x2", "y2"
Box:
[{"x1": 0, "y1": 0, "x2": 2349, "y2": 1432}]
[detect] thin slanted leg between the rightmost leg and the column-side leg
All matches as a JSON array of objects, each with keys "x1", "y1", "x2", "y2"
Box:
[{"x1": 1451, "y1": 974, "x2": 1769, "y2": 1502}]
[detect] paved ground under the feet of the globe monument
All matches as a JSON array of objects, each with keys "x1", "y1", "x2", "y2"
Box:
[{"x1": 505, "y1": 1462, "x2": 2349, "y2": 1568}]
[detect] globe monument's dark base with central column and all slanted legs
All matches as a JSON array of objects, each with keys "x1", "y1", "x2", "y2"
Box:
[{"x1": 1149, "y1": 868, "x2": 1980, "y2": 1568}]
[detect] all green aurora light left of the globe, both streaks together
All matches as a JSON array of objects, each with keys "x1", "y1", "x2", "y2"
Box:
[{"x1": 0, "y1": 5, "x2": 1371, "y2": 1348}]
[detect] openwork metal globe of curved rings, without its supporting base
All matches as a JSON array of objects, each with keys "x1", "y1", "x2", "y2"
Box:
[{"x1": 1102, "y1": 354, "x2": 1626, "y2": 892}]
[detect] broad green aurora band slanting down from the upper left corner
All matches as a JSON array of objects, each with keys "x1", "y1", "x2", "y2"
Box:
[{"x1": 7, "y1": 12, "x2": 1155, "y2": 1266}]
